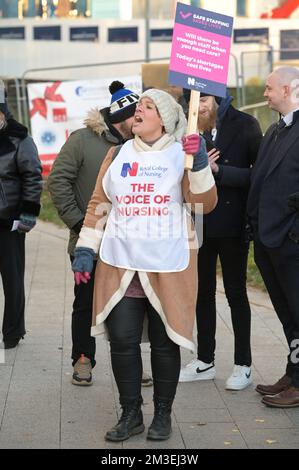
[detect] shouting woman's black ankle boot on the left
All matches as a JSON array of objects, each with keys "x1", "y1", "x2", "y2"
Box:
[{"x1": 105, "y1": 400, "x2": 144, "y2": 442}]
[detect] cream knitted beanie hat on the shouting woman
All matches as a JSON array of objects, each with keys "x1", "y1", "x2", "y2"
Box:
[{"x1": 140, "y1": 88, "x2": 187, "y2": 141}]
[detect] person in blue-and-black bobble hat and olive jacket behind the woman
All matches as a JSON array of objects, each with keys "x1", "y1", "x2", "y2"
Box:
[{"x1": 48, "y1": 80, "x2": 152, "y2": 386}]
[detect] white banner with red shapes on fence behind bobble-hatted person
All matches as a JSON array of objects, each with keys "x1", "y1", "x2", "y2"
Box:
[{"x1": 28, "y1": 75, "x2": 141, "y2": 177}]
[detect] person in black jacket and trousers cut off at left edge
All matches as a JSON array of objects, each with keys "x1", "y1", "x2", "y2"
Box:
[{"x1": 0, "y1": 83, "x2": 42, "y2": 349}]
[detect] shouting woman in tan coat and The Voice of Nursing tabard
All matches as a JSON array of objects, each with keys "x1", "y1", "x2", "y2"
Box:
[{"x1": 73, "y1": 89, "x2": 217, "y2": 442}]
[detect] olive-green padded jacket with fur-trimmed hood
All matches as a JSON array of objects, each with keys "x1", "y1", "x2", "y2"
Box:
[{"x1": 48, "y1": 108, "x2": 123, "y2": 255}]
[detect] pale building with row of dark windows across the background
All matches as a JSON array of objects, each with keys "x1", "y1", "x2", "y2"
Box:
[{"x1": 0, "y1": 0, "x2": 299, "y2": 87}]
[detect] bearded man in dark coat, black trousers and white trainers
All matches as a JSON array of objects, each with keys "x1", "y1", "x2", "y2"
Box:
[{"x1": 180, "y1": 90, "x2": 262, "y2": 390}]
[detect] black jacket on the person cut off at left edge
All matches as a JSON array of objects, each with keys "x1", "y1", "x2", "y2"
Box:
[{"x1": 0, "y1": 119, "x2": 42, "y2": 230}]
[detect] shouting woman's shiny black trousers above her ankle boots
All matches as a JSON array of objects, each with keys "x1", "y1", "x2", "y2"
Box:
[{"x1": 106, "y1": 297, "x2": 181, "y2": 405}]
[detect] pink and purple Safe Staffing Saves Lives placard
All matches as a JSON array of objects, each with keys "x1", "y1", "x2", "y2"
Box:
[{"x1": 169, "y1": 3, "x2": 233, "y2": 96}]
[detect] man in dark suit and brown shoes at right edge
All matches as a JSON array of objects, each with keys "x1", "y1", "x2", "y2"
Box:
[{"x1": 248, "y1": 67, "x2": 299, "y2": 408}]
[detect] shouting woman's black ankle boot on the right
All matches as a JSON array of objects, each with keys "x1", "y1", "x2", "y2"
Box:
[{"x1": 147, "y1": 398, "x2": 173, "y2": 441}]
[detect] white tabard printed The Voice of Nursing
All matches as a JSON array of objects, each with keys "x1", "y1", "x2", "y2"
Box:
[{"x1": 100, "y1": 140, "x2": 189, "y2": 272}]
